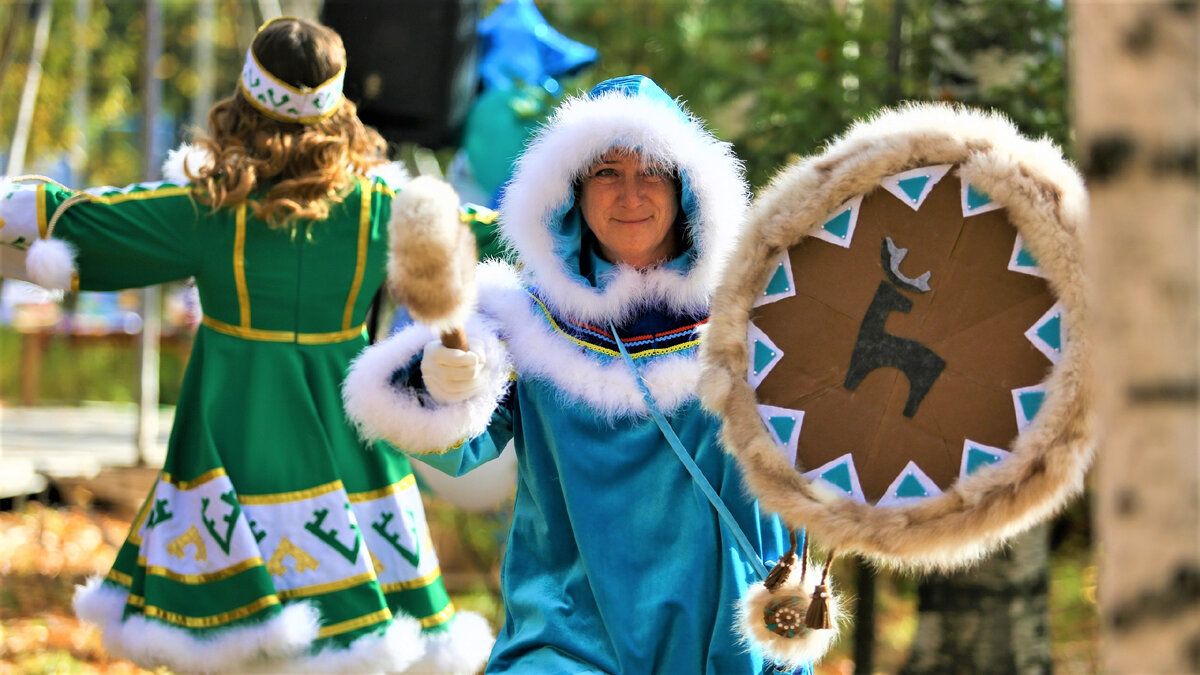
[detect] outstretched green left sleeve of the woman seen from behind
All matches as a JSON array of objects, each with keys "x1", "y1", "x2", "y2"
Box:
[{"x1": 37, "y1": 184, "x2": 205, "y2": 291}]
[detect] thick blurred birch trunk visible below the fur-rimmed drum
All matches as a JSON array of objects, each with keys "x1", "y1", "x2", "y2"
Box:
[{"x1": 901, "y1": 525, "x2": 1051, "y2": 675}]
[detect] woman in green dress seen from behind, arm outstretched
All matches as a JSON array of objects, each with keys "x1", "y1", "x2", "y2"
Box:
[{"x1": 0, "y1": 18, "x2": 493, "y2": 673}]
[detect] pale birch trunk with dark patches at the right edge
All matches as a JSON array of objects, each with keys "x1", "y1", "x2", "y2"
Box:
[{"x1": 1072, "y1": 0, "x2": 1200, "y2": 673}]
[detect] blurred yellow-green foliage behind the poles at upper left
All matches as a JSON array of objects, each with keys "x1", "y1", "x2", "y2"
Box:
[{"x1": 0, "y1": 0, "x2": 256, "y2": 185}]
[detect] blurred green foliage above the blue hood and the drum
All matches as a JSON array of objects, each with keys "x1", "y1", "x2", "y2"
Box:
[{"x1": 539, "y1": 0, "x2": 1067, "y2": 187}]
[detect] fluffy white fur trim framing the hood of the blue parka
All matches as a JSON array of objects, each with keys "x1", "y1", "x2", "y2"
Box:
[{"x1": 500, "y1": 79, "x2": 749, "y2": 321}]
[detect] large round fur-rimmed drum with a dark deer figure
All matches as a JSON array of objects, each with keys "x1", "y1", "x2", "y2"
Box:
[{"x1": 701, "y1": 104, "x2": 1093, "y2": 569}]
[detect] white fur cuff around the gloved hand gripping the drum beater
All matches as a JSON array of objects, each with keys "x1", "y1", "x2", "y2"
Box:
[{"x1": 342, "y1": 316, "x2": 512, "y2": 454}]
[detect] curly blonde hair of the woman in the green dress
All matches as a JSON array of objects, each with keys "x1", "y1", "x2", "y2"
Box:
[{"x1": 188, "y1": 18, "x2": 388, "y2": 227}]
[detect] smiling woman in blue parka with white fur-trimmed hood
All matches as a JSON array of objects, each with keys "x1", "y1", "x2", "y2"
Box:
[{"x1": 346, "y1": 76, "x2": 801, "y2": 674}]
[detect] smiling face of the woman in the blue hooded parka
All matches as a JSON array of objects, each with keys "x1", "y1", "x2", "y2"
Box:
[{"x1": 580, "y1": 148, "x2": 679, "y2": 269}]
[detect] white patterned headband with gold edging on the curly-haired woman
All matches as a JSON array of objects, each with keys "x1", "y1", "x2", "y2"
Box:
[{"x1": 238, "y1": 42, "x2": 346, "y2": 124}]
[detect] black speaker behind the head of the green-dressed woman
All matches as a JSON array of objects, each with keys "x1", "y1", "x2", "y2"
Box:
[{"x1": 320, "y1": 0, "x2": 481, "y2": 148}]
